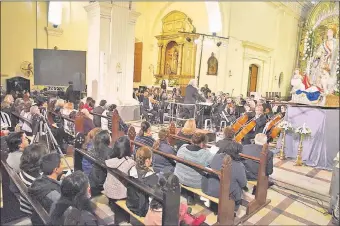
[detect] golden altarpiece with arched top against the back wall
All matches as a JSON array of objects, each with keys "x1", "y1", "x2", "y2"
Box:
[{"x1": 155, "y1": 11, "x2": 199, "y2": 91}]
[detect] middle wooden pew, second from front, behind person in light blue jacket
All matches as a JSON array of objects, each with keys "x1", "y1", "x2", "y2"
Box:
[{"x1": 128, "y1": 127, "x2": 235, "y2": 225}]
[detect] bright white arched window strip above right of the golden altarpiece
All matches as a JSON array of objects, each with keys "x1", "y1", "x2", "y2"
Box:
[{"x1": 205, "y1": 1, "x2": 222, "y2": 33}]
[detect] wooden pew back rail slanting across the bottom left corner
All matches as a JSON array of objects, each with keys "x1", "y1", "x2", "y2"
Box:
[{"x1": 1, "y1": 159, "x2": 50, "y2": 225}]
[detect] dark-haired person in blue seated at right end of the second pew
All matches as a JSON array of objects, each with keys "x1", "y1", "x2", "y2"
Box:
[{"x1": 202, "y1": 142, "x2": 248, "y2": 212}]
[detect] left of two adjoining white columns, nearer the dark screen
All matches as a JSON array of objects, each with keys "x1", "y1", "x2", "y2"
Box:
[{"x1": 84, "y1": 2, "x2": 112, "y2": 100}]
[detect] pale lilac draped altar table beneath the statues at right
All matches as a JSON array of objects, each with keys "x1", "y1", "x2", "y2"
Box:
[{"x1": 278, "y1": 106, "x2": 339, "y2": 170}]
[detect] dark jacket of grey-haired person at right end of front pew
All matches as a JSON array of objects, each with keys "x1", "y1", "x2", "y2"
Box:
[{"x1": 242, "y1": 144, "x2": 273, "y2": 180}]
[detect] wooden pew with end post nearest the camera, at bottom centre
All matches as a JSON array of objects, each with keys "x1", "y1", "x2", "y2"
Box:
[{"x1": 74, "y1": 149, "x2": 180, "y2": 225}]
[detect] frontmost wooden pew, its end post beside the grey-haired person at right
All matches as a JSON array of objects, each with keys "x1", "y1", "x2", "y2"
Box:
[{"x1": 169, "y1": 123, "x2": 270, "y2": 222}]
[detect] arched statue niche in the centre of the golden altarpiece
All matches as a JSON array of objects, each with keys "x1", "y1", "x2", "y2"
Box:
[{"x1": 165, "y1": 41, "x2": 178, "y2": 75}]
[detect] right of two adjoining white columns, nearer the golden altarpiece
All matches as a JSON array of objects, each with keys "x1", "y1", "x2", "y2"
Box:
[{"x1": 106, "y1": 2, "x2": 140, "y2": 106}]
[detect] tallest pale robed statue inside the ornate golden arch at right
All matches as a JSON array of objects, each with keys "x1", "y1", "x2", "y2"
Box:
[{"x1": 309, "y1": 28, "x2": 339, "y2": 89}]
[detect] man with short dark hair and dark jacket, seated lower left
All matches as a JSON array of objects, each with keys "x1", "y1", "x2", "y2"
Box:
[{"x1": 28, "y1": 153, "x2": 63, "y2": 225}]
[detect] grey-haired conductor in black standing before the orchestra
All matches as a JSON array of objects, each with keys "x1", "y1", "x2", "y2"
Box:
[{"x1": 179, "y1": 79, "x2": 205, "y2": 118}]
